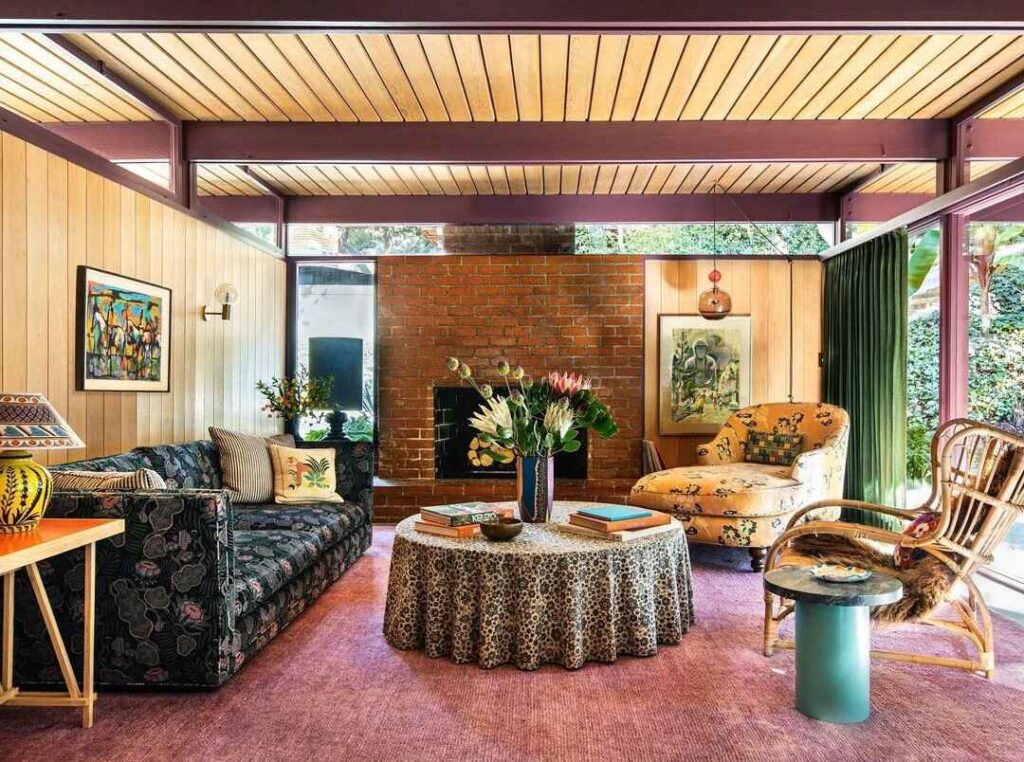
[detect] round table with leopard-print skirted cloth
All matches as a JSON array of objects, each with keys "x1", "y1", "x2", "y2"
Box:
[{"x1": 384, "y1": 501, "x2": 693, "y2": 670}]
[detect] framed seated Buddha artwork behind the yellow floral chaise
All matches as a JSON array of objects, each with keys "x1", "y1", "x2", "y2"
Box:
[{"x1": 657, "y1": 314, "x2": 754, "y2": 436}]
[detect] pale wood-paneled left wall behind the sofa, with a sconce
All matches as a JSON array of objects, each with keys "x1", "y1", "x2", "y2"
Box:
[{"x1": 0, "y1": 133, "x2": 286, "y2": 463}]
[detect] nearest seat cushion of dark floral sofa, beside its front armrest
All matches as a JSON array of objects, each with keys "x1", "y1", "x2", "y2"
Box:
[{"x1": 234, "y1": 530, "x2": 329, "y2": 616}]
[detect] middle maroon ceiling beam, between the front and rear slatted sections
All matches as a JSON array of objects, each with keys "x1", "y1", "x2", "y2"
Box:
[{"x1": 185, "y1": 119, "x2": 947, "y2": 164}]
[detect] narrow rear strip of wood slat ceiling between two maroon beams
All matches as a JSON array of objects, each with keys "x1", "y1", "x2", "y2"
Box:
[{"x1": 197, "y1": 163, "x2": 901, "y2": 196}]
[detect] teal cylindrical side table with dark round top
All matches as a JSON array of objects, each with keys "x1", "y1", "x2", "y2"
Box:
[{"x1": 765, "y1": 566, "x2": 903, "y2": 723}]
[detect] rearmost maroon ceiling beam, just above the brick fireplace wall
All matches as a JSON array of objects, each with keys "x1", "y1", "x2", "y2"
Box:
[{"x1": 198, "y1": 194, "x2": 837, "y2": 224}]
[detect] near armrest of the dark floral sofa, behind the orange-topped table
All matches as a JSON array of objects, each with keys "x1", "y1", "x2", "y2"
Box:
[{"x1": 15, "y1": 490, "x2": 234, "y2": 687}]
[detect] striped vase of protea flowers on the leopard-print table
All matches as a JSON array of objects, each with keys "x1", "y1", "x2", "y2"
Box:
[{"x1": 447, "y1": 357, "x2": 618, "y2": 521}]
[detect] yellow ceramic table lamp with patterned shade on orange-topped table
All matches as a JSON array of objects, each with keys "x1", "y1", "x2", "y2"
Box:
[{"x1": 0, "y1": 392, "x2": 85, "y2": 534}]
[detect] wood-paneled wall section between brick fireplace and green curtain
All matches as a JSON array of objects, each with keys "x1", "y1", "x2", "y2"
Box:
[{"x1": 644, "y1": 259, "x2": 821, "y2": 467}]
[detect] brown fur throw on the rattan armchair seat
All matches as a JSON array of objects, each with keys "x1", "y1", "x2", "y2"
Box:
[{"x1": 779, "y1": 535, "x2": 953, "y2": 624}]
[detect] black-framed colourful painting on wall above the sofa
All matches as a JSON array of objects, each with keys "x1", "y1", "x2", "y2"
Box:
[{"x1": 75, "y1": 264, "x2": 173, "y2": 392}]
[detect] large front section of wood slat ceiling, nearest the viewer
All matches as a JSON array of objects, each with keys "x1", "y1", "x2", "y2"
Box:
[{"x1": 6, "y1": 33, "x2": 1024, "y2": 122}]
